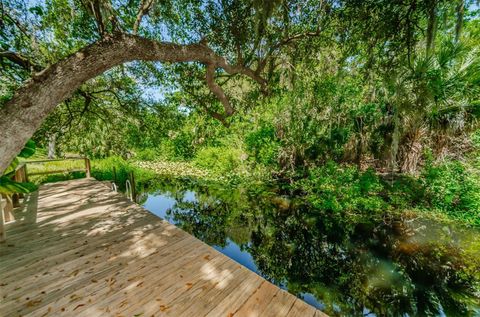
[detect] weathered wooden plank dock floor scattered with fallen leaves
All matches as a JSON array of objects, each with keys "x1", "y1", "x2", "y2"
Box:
[{"x1": 0, "y1": 179, "x2": 325, "y2": 317}]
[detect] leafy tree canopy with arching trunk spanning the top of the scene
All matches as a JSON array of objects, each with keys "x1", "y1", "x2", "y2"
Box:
[{"x1": 0, "y1": 0, "x2": 480, "y2": 172}]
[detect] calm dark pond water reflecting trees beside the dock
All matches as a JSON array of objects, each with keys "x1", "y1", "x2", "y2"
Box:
[{"x1": 142, "y1": 180, "x2": 480, "y2": 316}]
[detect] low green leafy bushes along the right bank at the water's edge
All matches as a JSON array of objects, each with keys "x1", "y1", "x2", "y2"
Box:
[{"x1": 293, "y1": 161, "x2": 480, "y2": 226}]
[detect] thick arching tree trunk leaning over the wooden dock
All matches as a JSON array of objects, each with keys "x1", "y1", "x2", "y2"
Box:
[{"x1": 0, "y1": 33, "x2": 265, "y2": 173}]
